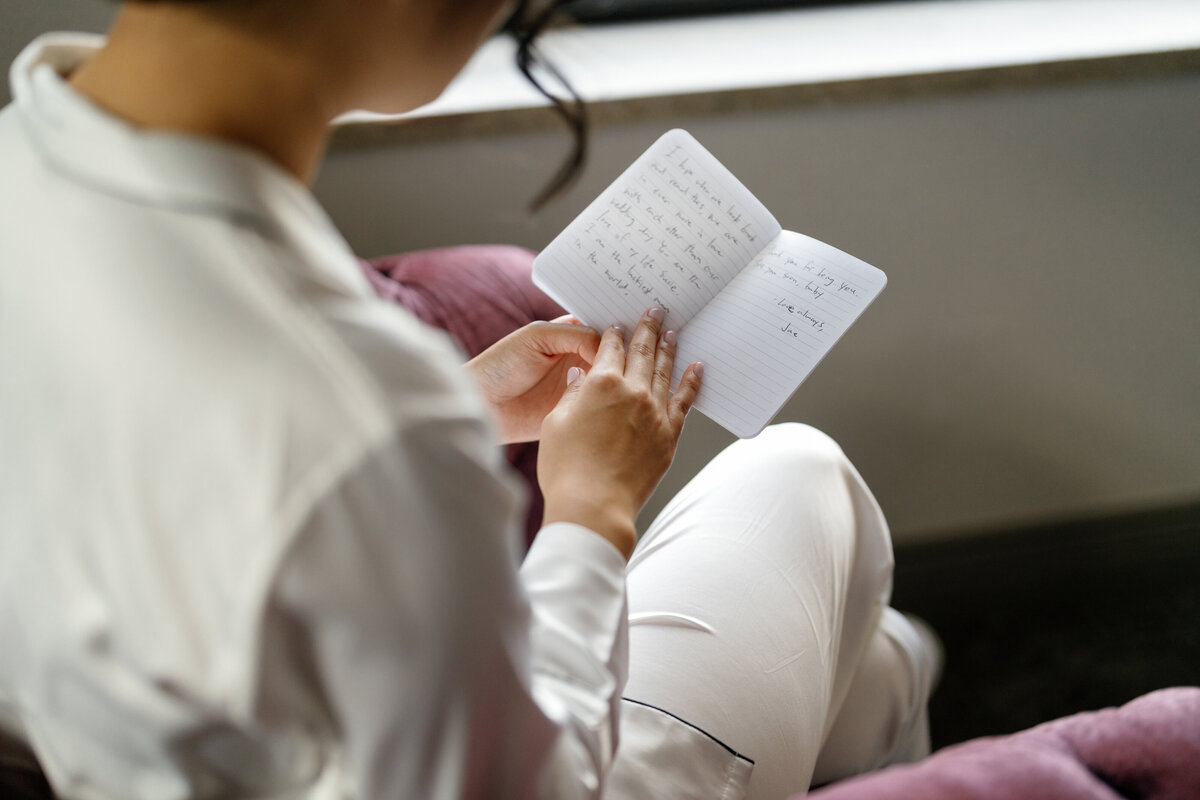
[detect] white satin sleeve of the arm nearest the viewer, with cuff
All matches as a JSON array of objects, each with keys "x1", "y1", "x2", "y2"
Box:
[{"x1": 259, "y1": 410, "x2": 628, "y2": 799}]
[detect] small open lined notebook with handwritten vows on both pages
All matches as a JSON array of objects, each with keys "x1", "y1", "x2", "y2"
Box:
[{"x1": 533, "y1": 130, "x2": 887, "y2": 438}]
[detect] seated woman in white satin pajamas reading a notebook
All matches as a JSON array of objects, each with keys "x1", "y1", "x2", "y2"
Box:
[{"x1": 0, "y1": 0, "x2": 935, "y2": 798}]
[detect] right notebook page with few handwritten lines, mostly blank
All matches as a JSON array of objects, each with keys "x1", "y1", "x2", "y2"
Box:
[{"x1": 673, "y1": 230, "x2": 887, "y2": 438}]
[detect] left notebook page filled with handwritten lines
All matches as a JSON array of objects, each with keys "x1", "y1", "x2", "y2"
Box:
[{"x1": 533, "y1": 130, "x2": 780, "y2": 331}]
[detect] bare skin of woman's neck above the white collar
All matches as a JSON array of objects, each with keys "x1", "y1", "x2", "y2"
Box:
[{"x1": 70, "y1": 4, "x2": 344, "y2": 182}]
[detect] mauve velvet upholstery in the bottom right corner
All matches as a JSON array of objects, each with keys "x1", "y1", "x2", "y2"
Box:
[{"x1": 793, "y1": 687, "x2": 1200, "y2": 800}]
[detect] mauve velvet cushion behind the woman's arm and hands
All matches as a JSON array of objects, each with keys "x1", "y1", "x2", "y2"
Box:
[{"x1": 361, "y1": 245, "x2": 565, "y2": 547}]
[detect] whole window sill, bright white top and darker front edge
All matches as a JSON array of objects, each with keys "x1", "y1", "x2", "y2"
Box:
[{"x1": 335, "y1": 0, "x2": 1200, "y2": 145}]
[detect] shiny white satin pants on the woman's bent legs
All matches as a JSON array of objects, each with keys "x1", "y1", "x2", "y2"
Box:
[{"x1": 606, "y1": 423, "x2": 940, "y2": 800}]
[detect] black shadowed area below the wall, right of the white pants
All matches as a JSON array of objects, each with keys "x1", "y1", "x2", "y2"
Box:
[{"x1": 893, "y1": 503, "x2": 1200, "y2": 748}]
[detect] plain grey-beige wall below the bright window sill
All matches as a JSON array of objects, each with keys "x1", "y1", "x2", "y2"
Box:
[{"x1": 317, "y1": 74, "x2": 1200, "y2": 540}]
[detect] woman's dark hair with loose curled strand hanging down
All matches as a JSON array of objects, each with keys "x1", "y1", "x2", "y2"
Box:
[{"x1": 115, "y1": 0, "x2": 588, "y2": 212}]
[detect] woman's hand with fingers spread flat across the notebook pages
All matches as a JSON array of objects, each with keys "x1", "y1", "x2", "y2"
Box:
[{"x1": 538, "y1": 303, "x2": 703, "y2": 559}]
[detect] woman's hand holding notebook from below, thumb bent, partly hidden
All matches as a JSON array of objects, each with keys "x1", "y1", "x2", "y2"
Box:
[{"x1": 467, "y1": 317, "x2": 600, "y2": 444}]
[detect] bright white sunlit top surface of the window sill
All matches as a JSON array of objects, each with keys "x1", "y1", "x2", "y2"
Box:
[{"x1": 344, "y1": 0, "x2": 1200, "y2": 121}]
